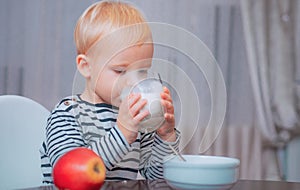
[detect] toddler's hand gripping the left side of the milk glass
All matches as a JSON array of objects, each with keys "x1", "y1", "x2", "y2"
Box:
[{"x1": 117, "y1": 94, "x2": 149, "y2": 144}]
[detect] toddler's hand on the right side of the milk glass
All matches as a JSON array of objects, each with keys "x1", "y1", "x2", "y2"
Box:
[{"x1": 156, "y1": 87, "x2": 176, "y2": 142}]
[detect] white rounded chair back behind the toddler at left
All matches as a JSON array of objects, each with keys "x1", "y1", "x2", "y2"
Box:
[{"x1": 0, "y1": 95, "x2": 50, "y2": 189}]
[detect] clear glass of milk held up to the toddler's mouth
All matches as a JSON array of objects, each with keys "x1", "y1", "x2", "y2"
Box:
[{"x1": 121, "y1": 70, "x2": 164, "y2": 133}]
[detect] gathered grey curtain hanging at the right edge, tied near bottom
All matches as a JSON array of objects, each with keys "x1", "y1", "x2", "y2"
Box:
[{"x1": 241, "y1": 0, "x2": 300, "y2": 179}]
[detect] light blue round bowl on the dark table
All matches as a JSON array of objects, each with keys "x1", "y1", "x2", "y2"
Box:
[{"x1": 163, "y1": 155, "x2": 240, "y2": 189}]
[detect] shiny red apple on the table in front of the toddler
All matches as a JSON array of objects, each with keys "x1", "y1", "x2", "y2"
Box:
[{"x1": 52, "y1": 147, "x2": 106, "y2": 190}]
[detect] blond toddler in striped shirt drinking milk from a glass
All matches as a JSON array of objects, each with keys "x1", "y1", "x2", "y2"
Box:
[{"x1": 40, "y1": 1, "x2": 180, "y2": 183}]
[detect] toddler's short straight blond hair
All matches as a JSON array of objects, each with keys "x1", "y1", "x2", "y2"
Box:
[{"x1": 74, "y1": 1, "x2": 152, "y2": 54}]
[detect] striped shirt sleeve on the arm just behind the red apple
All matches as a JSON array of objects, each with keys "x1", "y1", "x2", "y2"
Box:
[{"x1": 46, "y1": 107, "x2": 131, "y2": 169}]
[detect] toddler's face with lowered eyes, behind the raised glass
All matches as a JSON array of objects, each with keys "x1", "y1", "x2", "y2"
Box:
[{"x1": 90, "y1": 44, "x2": 153, "y2": 106}]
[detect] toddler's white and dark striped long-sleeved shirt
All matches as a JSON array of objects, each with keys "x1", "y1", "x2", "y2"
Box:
[{"x1": 40, "y1": 96, "x2": 180, "y2": 183}]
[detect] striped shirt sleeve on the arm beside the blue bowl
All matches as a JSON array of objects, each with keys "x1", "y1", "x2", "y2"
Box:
[{"x1": 140, "y1": 130, "x2": 180, "y2": 179}]
